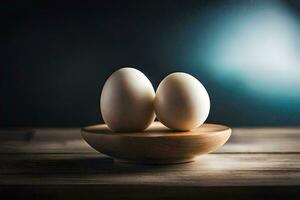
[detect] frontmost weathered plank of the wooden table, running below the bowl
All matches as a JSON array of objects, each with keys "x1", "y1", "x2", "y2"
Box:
[{"x1": 0, "y1": 154, "x2": 300, "y2": 186}]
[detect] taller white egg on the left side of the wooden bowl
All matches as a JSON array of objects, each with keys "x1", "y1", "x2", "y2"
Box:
[{"x1": 100, "y1": 67, "x2": 155, "y2": 132}]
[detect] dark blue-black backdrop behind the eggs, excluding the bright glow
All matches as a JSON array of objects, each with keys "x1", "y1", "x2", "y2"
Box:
[{"x1": 0, "y1": 0, "x2": 300, "y2": 126}]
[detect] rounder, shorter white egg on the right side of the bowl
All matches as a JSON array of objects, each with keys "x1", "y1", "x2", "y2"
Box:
[{"x1": 154, "y1": 72, "x2": 210, "y2": 131}]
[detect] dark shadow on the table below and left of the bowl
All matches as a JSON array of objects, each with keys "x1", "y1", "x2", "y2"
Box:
[{"x1": 0, "y1": 155, "x2": 204, "y2": 175}]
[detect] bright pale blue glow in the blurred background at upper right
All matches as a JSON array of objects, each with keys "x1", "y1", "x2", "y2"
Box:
[{"x1": 197, "y1": 1, "x2": 300, "y2": 100}]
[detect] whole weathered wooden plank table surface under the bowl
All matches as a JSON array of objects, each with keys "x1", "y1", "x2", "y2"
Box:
[{"x1": 0, "y1": 128, "x2": 300, "y2": 199}]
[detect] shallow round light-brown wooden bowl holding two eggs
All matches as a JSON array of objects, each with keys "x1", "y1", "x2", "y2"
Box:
[{"x1": 81, "y1": 122, "x2": 231, "y2": 164}]
